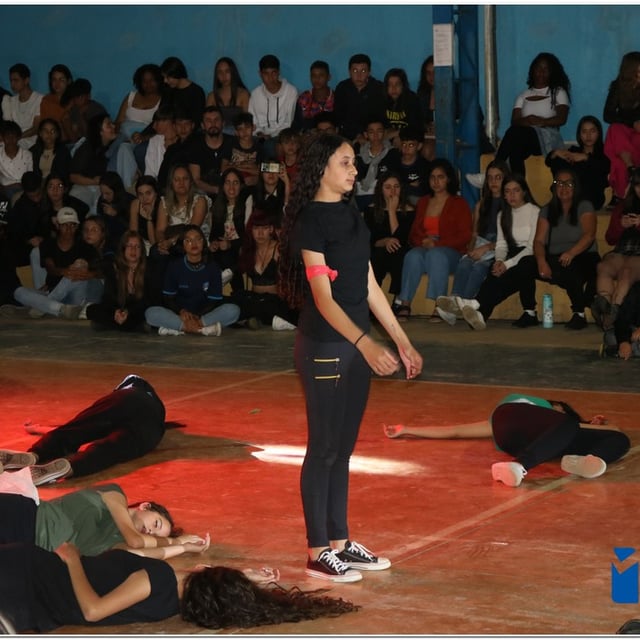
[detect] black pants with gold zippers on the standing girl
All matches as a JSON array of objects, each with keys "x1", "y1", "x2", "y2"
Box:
[{"x1": 295, "y1": 332, "x2": 371, "y2": 547}]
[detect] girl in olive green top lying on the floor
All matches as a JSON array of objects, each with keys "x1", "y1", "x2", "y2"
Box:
[{"x1": 0, "y1": 468, "x2": 209, "y2": 559}]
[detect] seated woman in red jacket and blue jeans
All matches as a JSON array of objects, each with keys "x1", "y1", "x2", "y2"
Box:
[{"x1": 392, "y1": 158, "x2": 472, "y2": 322}]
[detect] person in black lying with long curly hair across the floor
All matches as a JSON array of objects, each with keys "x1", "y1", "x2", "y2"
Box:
[{"x1": 0, "y1": 542, "x2": 358, "y2": 633}]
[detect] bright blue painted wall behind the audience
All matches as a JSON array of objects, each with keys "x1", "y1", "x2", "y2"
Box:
[{"x1": 0, "y1": 5, "x2": 640, "y2": 140}]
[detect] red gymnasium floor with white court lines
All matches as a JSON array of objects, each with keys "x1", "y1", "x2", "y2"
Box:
[{"x1": 0, "y1": 350, "x2": 640, "y2": 635}]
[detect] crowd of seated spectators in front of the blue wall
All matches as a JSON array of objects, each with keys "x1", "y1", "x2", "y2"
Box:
[{"x1": 0, "y1": 52, "x2": 640, "y2": 358}]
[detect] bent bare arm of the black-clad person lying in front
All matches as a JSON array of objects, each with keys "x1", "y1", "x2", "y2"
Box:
[{"x1": 56, "y1": 542, "x2": 151, "y2": 622}]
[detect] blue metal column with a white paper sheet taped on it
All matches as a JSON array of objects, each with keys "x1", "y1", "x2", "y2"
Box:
[{"x1": 433, "y1": 5, "x2": 456, "y2": 165}]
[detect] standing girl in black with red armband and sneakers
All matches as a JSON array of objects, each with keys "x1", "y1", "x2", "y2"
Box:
[{"x1": 280, "y1": 135, "x2": 422, "y2": 582}]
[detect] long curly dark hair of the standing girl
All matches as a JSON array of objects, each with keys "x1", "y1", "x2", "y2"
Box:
[{"x1": 278, "y1": 134, "x2": 351, "y2": 309}]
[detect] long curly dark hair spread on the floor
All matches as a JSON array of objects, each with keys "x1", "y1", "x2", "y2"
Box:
[{"x1": 180, "y1": 567, "x2": 359, "y2": 629}]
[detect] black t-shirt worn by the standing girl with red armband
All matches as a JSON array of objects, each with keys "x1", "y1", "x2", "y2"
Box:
[{"x1": 293, "y1": 202, "x2": 370, "y2": 342}]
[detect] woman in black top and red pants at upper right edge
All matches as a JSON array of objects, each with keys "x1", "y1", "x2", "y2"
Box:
[{"x1": 603, "y1": 51, "x2": 640, "y2": 200}]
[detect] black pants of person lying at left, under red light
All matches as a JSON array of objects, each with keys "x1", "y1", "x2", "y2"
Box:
[{"x1": 29, "y1": 383, "x2": 165, "y2": 477}]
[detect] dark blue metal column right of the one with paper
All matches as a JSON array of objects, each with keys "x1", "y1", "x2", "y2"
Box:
[{"x1": 456, "y1": 5, "x2": 480, "y2": 205}]
